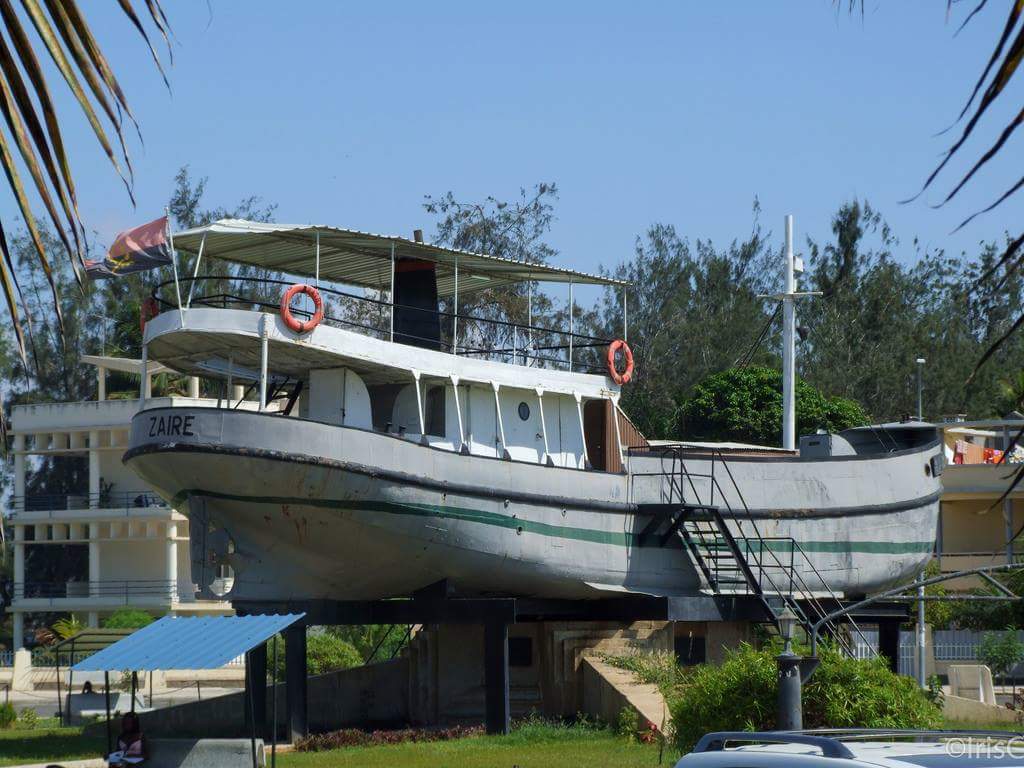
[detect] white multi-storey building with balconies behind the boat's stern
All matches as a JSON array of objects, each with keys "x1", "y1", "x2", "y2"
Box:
[{"x1": 7, "y1": 356, "x2": 234, "y2": 648}]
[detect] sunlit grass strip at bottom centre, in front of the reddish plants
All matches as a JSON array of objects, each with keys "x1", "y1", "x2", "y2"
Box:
[{"x1": 278, "y1": 727, "x2": 677, "y2": 768}]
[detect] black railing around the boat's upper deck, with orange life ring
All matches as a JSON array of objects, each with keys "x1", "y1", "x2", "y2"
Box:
[{"x1": 153, "y1": 274, "x2": 610, "y2": 374}]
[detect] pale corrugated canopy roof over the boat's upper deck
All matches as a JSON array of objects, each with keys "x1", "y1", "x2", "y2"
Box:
[{"x1": 174, "y1": 219, "x2": 627, "y2": 296}]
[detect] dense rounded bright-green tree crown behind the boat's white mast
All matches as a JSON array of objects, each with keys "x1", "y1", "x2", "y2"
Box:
[{"x1": 673, "y1": 366, "x2": 868, "y2": 445}]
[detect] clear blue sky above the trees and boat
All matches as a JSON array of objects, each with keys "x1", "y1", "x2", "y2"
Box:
[{"x1": 28, "y1": 0, "x2": 1021, "y2": 286}]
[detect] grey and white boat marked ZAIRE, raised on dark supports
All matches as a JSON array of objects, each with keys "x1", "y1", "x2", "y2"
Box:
[{"x1": 124, "y1": 219, "x2": 942, "y2": 618}]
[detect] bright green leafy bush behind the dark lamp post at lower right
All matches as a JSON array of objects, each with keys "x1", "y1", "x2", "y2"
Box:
[{"x1": 643, "y1": 644, "x2": 942, "y2": 751}]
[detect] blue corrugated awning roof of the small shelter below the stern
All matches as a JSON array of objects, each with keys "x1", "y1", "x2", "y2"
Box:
[{"x1": 72, "y1": 613, "x2": 305, "y2": 672}]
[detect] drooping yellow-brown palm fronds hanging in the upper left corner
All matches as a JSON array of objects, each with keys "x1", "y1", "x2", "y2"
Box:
[{"x1": 0, "y1": 0, "x2": 170, "y2": 446}]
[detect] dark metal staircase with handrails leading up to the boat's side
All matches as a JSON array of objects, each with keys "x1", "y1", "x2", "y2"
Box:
[{"x1": 631, "y1": 444, "x2": 860, "y2": 654}]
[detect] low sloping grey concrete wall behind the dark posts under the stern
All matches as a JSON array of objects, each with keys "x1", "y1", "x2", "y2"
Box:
[{"x1": 122, "y1": 658, "x2": 409, "y2": 738}]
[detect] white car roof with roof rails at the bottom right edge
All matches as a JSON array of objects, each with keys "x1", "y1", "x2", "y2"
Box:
[{"x1": 676, "y1": 729, "x2": 1024, "y2": 768}]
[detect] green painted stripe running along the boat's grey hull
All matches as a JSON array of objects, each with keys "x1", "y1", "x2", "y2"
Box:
[{"x1": 171, "y1": 489, "x2": 935, "y2": 555}]
